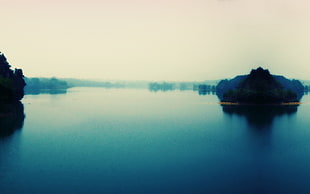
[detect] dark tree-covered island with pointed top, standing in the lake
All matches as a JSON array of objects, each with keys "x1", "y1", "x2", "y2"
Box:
[{"x1": 216, "y1": 67, "x2": 304, "y2": 104}]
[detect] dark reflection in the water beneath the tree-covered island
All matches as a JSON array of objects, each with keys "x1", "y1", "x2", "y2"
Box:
[{"x1": 222, "y1": 105, "x2": 298, "y2": 129}]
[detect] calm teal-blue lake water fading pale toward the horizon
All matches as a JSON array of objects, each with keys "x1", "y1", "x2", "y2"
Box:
[{"x1": 0, "y1": 88, "x2": 310, "y2": 193}]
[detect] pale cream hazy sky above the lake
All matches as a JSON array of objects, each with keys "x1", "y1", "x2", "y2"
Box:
[{"x1": 0, "y1": 0, "x2": 310, "y2": 81}]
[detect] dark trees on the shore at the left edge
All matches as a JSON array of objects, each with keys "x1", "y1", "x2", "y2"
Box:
[{"x1": 0, "y1": 52, "x2": 26, "y2": 102}]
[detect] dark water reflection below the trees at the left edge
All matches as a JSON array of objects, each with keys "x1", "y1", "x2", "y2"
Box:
[{"x1": 0, "y1": 102, "x2": 25, "y2": 138}]
